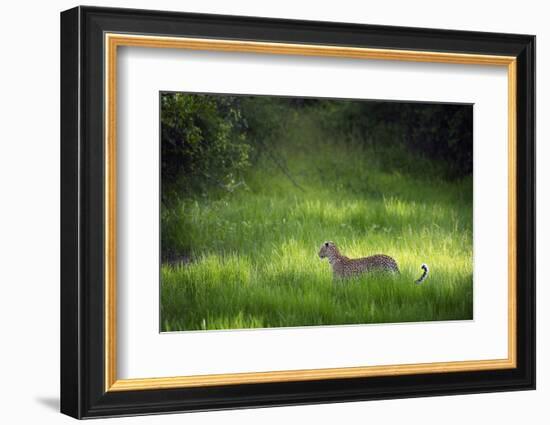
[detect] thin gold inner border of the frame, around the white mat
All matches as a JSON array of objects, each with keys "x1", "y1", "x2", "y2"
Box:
[{"x1": 104, "y1": 33, "x2": 517, "y2": 391}]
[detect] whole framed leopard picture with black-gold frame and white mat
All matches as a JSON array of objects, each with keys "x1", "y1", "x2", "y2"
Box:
[{"x1": 61, "y1": 7, "x2": 535, "y2": 418}]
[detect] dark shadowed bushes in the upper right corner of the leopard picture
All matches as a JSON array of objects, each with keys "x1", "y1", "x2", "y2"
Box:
[{"x1": 321, "y1": 101, "x2": 473, "y2": 179}]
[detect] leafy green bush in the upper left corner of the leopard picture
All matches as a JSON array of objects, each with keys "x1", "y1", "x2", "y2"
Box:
[{"x1": 161, "y1": 93, "x2": 250, "y2": 203}]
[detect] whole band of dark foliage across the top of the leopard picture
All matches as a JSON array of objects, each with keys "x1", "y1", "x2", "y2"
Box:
[{"x1": 161, "y1": 93, "x2": 473, "y2": 209}]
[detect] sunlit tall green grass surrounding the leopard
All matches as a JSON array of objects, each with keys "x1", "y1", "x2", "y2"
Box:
[{"x1": 161, "y1": 109, "x2": 473, "y2": 331}]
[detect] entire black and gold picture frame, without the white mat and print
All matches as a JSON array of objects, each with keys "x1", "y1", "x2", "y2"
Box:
[{"x1": 61, "y1": 7, "x2": 535, "y2": 418}]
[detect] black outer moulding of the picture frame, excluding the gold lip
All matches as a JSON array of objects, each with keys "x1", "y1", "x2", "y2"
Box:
[{"x1": 61, "y1": 6, "x2": 535, "y2": 418}]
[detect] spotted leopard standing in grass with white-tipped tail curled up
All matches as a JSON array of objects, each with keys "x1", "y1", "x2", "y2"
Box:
[{"x1": 319, "y1": 241, "x2": 429, "y2": 284}]
